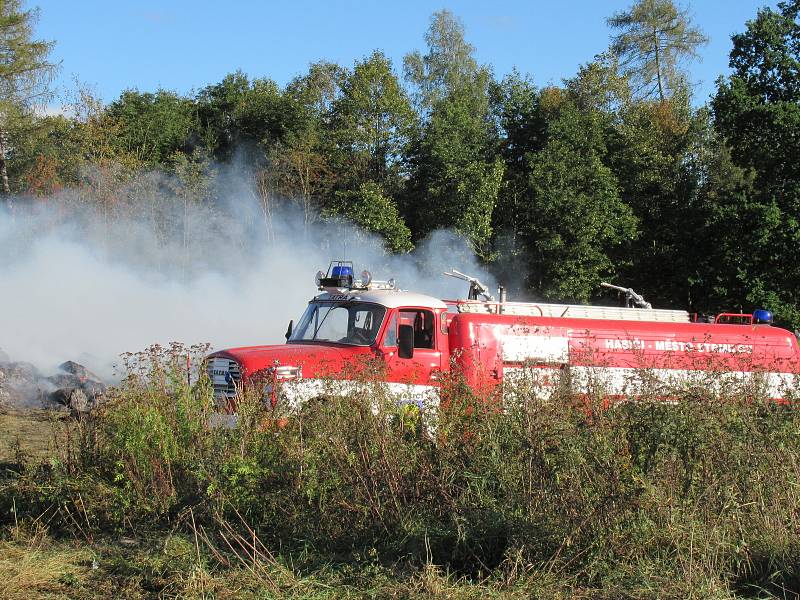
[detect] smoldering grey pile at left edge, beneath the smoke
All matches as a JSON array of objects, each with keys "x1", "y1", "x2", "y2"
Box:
[{"x1": 0, "y1": 350, "x2": 107, "y2": 414}]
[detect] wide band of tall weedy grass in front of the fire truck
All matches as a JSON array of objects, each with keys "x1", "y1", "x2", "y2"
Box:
[{"x1": 0, "y1": 346, "x2": 800, "y2": 598}]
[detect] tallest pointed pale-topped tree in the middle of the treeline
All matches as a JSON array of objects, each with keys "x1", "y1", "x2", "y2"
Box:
[{"x1": 402, "y1": 11, "x2": 503, "y2": 259}]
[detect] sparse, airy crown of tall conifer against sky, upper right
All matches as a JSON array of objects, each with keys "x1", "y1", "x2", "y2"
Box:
[{"x1": 608, "y1": 0, "x2": 708, "y2": 100}]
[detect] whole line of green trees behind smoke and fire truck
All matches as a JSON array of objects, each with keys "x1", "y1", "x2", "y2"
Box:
[{"x1": 0, "y1": 0, "x2": 800, "y2": 326}]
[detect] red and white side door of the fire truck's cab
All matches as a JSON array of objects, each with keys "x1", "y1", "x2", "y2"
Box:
[{"x1": 381, "y1": 308, "x2": 442, "y2": 386}]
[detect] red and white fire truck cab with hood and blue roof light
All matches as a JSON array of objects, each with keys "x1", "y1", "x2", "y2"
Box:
[{"x1": 207, "y1": 262, "x2": 449, "y2": 409}]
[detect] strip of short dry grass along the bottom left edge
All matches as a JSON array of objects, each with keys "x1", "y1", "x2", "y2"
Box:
[{"x1": 0, "y1": 533, "x2": 552, "y2": 600}]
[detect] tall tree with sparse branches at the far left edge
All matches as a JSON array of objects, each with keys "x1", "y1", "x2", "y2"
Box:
[{"x1": 0, "y1": 0, "x2": 56, "y2": 206}]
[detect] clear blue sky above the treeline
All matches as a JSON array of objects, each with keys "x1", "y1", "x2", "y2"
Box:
[{"x1": 36, "y1": 0, "x2": 776, "y2": 104}]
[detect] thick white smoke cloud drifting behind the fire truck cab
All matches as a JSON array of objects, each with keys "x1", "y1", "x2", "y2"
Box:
[{"x1": 0, "y1": 164, "x2": 494, "y2": 378}]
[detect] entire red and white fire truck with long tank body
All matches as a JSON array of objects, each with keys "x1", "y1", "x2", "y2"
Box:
[{"x1": 207, "y1": 262, "x2": 800, "y2": 410}]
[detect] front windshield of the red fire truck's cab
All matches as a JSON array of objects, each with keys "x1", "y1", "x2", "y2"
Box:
[{"x1": 289, "y1": 302, "x2": 386, "y2": 346}]
